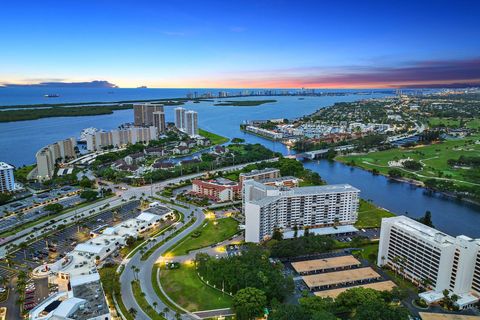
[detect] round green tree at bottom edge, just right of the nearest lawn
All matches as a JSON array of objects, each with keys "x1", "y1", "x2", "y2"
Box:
[{"x1": 232, "y1": 287, "x2": 267, "y2": 320}]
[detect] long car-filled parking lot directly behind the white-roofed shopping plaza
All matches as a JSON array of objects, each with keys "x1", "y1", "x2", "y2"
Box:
[{"x1": 8, "y1": 201, "x2": 139, "y2": 268}]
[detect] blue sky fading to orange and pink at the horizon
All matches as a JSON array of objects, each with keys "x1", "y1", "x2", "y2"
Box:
[{"x1": 0, "y1": 0, "x2": 480, "y2": 87}]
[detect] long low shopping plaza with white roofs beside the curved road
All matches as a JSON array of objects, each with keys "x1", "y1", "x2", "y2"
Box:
[{"x1": 29, "y1": 206, "x2": 173, "y2": 320}]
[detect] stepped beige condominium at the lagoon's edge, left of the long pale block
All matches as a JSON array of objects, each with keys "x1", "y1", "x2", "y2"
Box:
[{"x1": 35, "y1": 138, "x2": 77, "y2": 180}]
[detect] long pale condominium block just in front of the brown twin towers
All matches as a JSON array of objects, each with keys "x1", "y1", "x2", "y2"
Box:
[{"x1": 86, "y1": 126, "x2": 158, "y2": 151}]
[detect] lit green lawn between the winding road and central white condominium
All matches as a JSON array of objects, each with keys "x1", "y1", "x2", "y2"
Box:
[{"x1": 170, "y1": 218, "x2": 238, "y2": 256}]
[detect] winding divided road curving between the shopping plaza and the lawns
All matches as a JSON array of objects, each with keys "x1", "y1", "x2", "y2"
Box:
[{"x1": 120, "y1": 200, "x2": 205, "y2": 320}]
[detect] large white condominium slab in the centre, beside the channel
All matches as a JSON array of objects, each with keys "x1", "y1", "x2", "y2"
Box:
[{"x1": 243, "y1": 180, "x2": 360, "y2": 242}]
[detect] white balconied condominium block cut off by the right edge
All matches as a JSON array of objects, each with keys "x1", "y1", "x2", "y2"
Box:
[{"x1": 377, "y1": 216, "x2": 480, "y2": 309}]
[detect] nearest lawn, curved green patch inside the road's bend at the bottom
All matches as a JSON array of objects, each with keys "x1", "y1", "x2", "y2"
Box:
[{"x1": 160, "y1": 264, "x2": 232, "y2": 311}]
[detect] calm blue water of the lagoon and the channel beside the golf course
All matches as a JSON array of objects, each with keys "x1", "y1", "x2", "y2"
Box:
[{"x1": 0, "y1": 89, "x2": 480, "y2": 237}]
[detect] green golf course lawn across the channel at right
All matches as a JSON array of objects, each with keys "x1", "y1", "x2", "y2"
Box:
[{"x1": 336, "y1": 135, "x2": 480, "y2": 186}]
